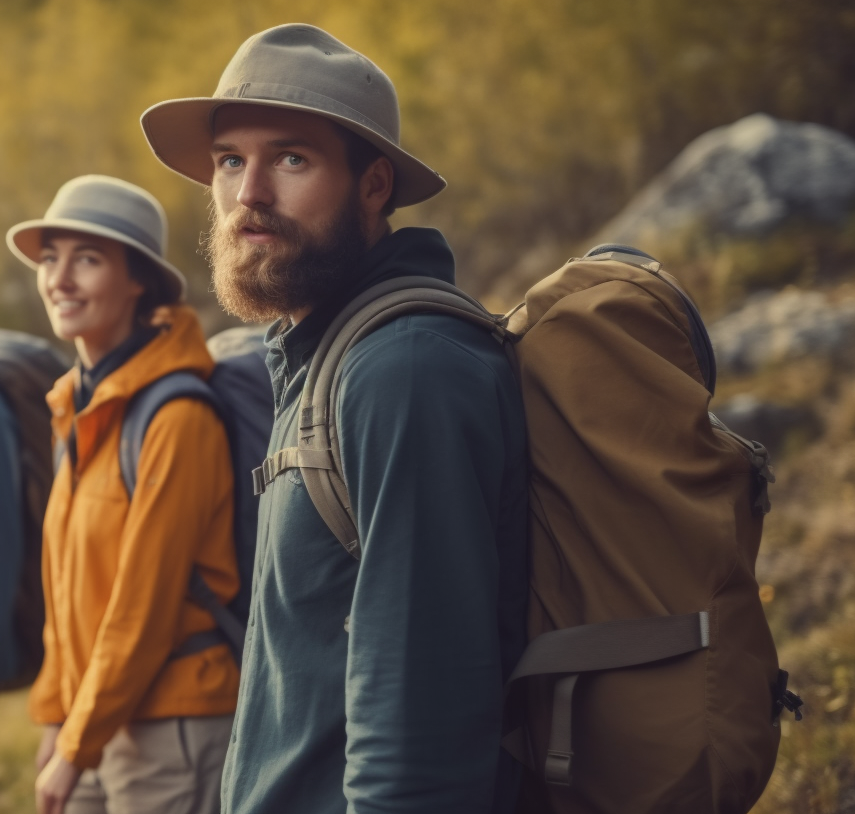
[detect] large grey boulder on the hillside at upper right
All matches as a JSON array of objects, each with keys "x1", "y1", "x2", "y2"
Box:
[{"x1": 604, "y1": 113, "x2": 855, "y2": 243}]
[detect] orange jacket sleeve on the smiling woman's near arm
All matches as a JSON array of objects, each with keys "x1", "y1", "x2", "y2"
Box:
[{"x1": 57, "y1": 399, "x2": 233, "y2": 768}]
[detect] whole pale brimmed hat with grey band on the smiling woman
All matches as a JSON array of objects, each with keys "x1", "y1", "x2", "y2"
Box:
[{"x1": 6, "y1": 175, "x2": 187, "y2": 300}]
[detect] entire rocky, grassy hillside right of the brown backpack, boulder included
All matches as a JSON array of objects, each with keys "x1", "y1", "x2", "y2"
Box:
[{"x1": 596, "y1": 114, "x2": 855, "y2": 814}]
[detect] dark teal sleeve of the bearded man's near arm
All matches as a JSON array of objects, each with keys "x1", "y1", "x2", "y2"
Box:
[{"x1": 337, "y1": 320, "x2": 510, "y2": 814}]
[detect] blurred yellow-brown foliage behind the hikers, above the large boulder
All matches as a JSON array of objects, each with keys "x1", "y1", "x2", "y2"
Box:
[{"x1": 0, "y1": 0, "x2": 855, "y2": 327}]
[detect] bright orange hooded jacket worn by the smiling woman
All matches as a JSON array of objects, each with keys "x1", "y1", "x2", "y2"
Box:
[{"x1": 30, "y1": 306, "x2": 239, "y2": 769}]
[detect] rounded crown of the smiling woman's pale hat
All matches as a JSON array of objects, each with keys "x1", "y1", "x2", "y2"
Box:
[{"x1": 45, "y1": 175, "x2": 167, "y2": 257}]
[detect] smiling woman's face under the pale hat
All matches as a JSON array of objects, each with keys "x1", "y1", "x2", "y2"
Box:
[{"x1": 38, "y1": 230, "x2": 144, "y2": 367}]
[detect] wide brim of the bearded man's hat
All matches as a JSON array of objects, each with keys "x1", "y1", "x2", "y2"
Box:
[{"x1": 140, "y1": 97, "x2": 446, "y2": 206}]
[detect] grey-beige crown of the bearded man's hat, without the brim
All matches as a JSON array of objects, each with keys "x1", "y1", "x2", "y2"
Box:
[{"x1": 214, "y1": 23, "x2": 401, "y2": 145}]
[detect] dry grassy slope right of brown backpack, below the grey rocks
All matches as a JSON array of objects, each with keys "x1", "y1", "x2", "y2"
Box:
[{"x1": 722, "y1": 304, "x2": 855, "y2": 814}]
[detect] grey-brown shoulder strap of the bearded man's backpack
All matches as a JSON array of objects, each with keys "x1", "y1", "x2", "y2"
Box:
[{"x1": 253, "y1": 277, "x2": 513, "y2": 559}]
